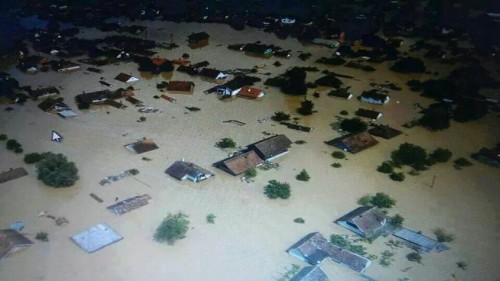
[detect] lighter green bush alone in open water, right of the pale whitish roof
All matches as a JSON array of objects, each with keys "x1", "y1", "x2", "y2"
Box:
[{"x1": 154, "y1": 212, "x2": 189, "y2": 244}]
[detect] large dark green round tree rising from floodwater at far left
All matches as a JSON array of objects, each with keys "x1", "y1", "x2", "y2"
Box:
[{"x1": 37, "y1": 152, "x2": 79, "y2": 188}]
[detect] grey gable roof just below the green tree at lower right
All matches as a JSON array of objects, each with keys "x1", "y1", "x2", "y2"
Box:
[{"x1": 335, "y1": 206, "x2": 389, "y2": 236}]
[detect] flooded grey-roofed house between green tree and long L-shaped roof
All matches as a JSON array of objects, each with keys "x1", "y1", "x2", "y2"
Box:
[{"x1": 335, "y1": 206, "x2": 390, "y2": 238}]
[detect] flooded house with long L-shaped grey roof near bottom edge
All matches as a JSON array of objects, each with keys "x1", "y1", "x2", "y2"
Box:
[{"x1": 287, "y1": 232, "x2": 371, "y2": 274}]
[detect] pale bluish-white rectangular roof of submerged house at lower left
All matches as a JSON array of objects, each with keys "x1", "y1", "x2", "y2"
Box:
[{"x1": 71, "y1": 223, "x2": 123, "y2": 253}]
